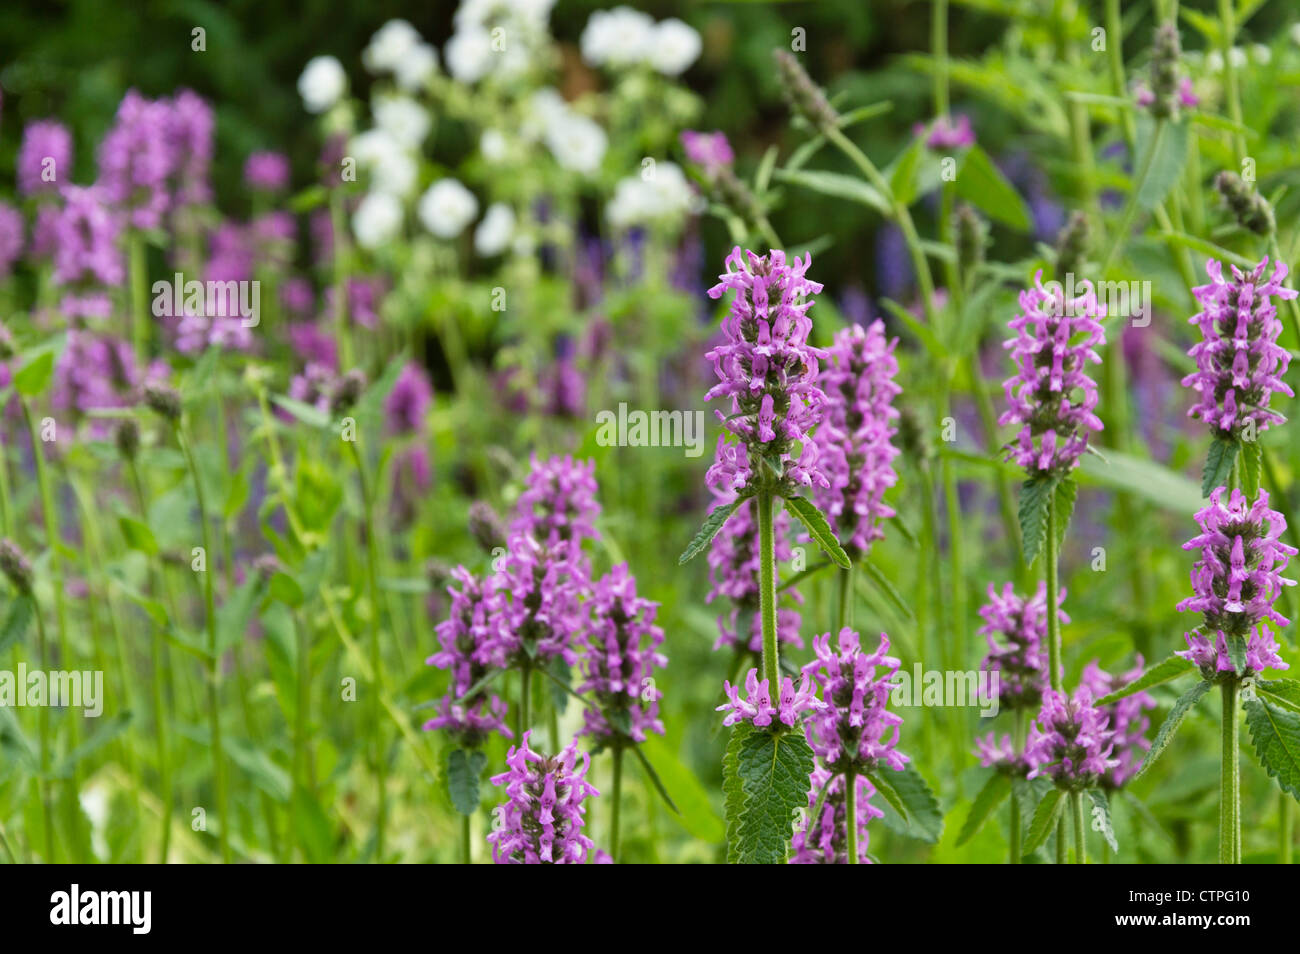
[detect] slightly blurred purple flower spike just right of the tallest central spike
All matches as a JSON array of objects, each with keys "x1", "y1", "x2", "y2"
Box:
[{"x1": 813, "y1": 320, "x2": 902, "y2": 558}]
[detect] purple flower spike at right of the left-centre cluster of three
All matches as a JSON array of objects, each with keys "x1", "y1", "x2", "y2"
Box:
[{"x1": 577, "y1": 563, "x2": 668, "y2": 743}]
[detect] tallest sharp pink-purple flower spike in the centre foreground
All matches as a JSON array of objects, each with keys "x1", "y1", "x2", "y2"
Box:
[{"x1": 705, "y1": 246, "x2": 828, "y2": 490}]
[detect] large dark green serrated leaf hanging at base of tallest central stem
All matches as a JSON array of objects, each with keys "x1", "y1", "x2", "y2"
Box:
[{"x1": 723, "y1": 723, "x2": 814, "y2": 864}]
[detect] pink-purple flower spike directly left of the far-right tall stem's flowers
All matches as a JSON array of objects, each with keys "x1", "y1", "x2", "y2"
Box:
[{"x1": 998, "y1": 272, "x2": 1106, "y2": 477}]
